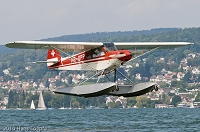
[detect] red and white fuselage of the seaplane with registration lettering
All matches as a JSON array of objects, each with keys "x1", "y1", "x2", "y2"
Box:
[{"x1": 48, "y1": 50, "x2": 132, "y2": 70}]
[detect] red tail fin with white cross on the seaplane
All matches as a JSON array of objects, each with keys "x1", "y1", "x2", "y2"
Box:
[{"x1": 47, "y1": 50, "x2": 61, "y2": 68}]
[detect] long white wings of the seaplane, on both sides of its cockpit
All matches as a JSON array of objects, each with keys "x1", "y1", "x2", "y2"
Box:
[{"x1": 5, "y1": 41, "x2": 193, "y2": 52}]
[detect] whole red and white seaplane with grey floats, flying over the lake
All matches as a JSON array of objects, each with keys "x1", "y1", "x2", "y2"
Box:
[{"x1": 6, "y1": 41, "x2": 192, "y2": 97}]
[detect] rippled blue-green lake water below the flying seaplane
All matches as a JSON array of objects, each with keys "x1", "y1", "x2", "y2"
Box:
[{"x1": 0, "y1": 108, "x2": 200, "y2": 132}]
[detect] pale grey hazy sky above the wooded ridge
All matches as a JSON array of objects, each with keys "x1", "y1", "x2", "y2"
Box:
[{"x1": 0, "y1": 0, "x2": 200, "y2": 44}]
